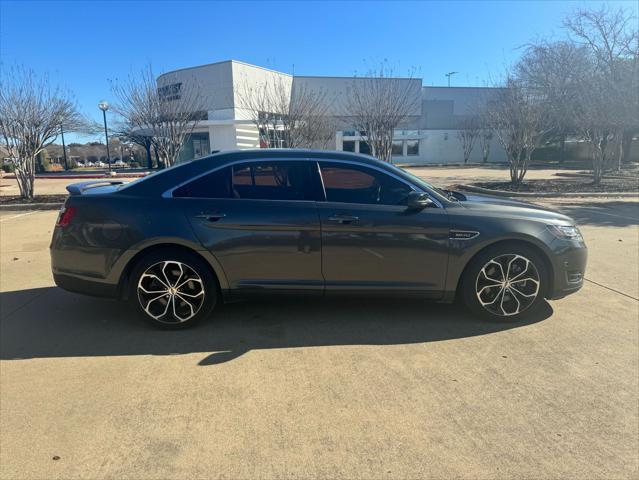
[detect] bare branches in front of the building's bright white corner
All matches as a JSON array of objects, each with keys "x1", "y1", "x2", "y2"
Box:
[{"x1": 237, "y1": 77, "x2": 335, "y2": 148}]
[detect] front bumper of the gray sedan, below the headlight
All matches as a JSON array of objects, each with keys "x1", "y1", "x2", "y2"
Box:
[{"x1": 548, "y1": 241, "x2": 588, "y2": 300}]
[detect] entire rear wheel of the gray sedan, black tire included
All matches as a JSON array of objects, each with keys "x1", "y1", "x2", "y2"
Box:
[{"x1": 128, "y1": 248, "x2": 218, "y2": 330}]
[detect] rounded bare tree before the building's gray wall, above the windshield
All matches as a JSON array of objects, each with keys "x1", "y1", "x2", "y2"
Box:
[{"x1": 344, "y1": 64, "x2": 421, "y2": 162}]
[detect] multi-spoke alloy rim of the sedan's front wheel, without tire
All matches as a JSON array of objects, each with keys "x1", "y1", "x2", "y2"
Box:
[{"x1": 475, "y1": 254, "x2": 540, "y2": 317}]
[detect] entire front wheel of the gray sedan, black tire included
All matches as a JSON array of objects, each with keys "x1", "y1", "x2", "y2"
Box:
[{"x1": 460, "y1": 243, "x2": 549, "y2": 322}]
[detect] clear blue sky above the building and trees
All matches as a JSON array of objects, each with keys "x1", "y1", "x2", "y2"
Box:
[{"x1": 0, "y1": 0, "x2": 637, "y2": 142}]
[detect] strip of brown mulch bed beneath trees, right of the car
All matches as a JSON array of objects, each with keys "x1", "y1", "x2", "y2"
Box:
[{"x1": 471, "y1": 177, "x2": 639, "y2": 193}]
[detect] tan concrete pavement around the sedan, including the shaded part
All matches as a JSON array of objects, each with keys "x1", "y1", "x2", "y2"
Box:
[{"x1": 0, "y1": 200, "x2": 639, "y2": 479}]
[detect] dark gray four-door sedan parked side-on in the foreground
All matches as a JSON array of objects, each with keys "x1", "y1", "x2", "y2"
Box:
[{"x1": 51, "y1": 150, "x2": 587, "y2": 328}]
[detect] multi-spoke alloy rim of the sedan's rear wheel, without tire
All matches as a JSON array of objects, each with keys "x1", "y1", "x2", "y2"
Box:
[{"x1": 137, "y1": 260, "x2": 204, "y2": 323}]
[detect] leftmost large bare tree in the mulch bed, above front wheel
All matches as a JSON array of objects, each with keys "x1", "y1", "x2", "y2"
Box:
[{"x1": 486, "y1": 78, "x2": 552, "y2": 185}]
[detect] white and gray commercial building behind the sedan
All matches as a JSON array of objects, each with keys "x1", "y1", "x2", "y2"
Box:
[{"x1": 157, "y1": 60, "x2": 506, "y2": 165}]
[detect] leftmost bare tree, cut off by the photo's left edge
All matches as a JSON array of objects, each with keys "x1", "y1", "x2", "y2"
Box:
[{"x1": 0, "y1": 67, "x2": 85, "y2": 199}]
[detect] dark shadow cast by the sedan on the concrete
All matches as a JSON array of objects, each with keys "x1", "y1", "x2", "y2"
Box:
[{"x1": 0, "y1": 287, "x2": 552, "y2": 366}]
